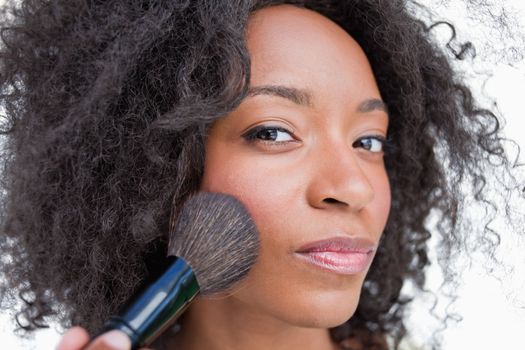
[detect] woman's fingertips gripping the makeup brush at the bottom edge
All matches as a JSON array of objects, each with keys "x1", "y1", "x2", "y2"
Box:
[{"x1": 56, "y1": 327, "x2": 146, "y2": 350}]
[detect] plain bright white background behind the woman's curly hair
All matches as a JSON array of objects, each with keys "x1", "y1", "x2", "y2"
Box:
[{"x1": 0, "y1": 0, "x2": 525, "y2": 350}]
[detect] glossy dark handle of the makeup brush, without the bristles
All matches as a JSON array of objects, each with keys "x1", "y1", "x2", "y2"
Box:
[{"x1": 104, "y1": 257, "x2": 199, "y2": 349}]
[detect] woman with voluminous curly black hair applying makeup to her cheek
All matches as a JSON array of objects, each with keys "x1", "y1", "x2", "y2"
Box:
[{"x1": 2, "y1": 0, "x2": 509, "y2": 350}]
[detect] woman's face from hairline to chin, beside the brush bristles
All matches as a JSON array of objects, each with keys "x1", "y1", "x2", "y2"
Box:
[{"x1": 201, "y1": 5, "x2": 390, "y2": 327}]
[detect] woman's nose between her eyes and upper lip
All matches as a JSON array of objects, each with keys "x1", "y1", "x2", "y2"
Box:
[{"x1": 306, "y1": 139, "x2": 374, "y2": 211}]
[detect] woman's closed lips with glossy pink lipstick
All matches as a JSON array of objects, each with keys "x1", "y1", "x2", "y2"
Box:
[{"x1": 295, "y1": 237, "x2": 377, "y2": 275}]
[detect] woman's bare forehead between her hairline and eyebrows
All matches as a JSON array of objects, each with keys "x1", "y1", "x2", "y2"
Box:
[{"x1": 246, "y1": 5, "x2": 379, "y2": 105}]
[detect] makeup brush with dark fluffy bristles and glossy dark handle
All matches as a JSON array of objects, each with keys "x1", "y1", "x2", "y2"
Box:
[{"x1": 97, "y1": 192, "x2": 259, "y2": 349}]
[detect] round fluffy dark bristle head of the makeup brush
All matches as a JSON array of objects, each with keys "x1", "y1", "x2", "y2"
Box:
[{"x1": 168, "y1": 192, "x2": 259, "y2": 295}]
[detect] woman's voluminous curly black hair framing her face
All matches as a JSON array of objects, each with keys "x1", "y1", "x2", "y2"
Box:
[{"x1": 0, "y1": 0, "x2": 511, "y2": 349}]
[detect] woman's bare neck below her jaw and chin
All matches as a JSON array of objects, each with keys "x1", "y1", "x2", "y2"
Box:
[{"x1": 170, "y1": 298, "x2": 337, "y2": 350}]
